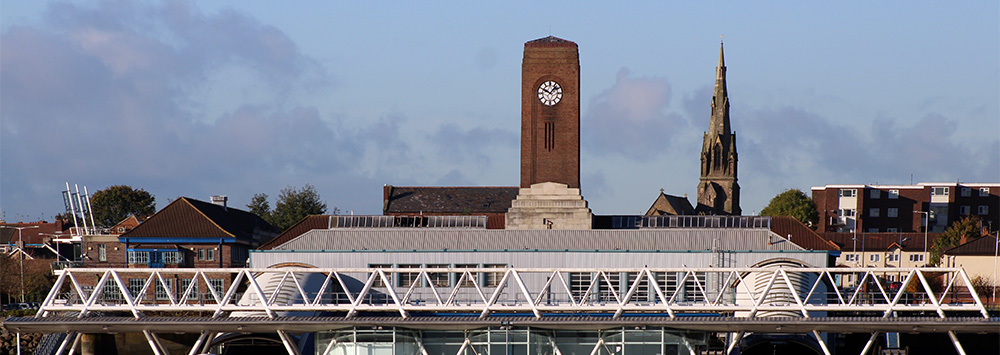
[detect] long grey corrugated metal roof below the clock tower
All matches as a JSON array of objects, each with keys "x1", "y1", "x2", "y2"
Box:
[{"x1": 274, "y1": 228, "x2": 804, "y2": 251}]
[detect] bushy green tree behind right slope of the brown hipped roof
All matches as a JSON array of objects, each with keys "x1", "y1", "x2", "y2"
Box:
[{"x1": 247, "y1": 184, "x2": 340, "y2": 230}]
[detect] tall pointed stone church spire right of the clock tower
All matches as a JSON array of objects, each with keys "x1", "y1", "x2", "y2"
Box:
[{"x1": 696, "y1": 43, "x2": 742, "y2": 215}]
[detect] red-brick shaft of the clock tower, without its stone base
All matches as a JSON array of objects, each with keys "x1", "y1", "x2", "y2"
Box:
[{"x1": 521, "y1": 36, "x2": 580, "y2": 188}]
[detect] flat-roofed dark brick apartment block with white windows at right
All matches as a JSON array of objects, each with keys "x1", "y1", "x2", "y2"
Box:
[{"x1": 812, "y1": 182, "x2": 1000, "y2": 233}]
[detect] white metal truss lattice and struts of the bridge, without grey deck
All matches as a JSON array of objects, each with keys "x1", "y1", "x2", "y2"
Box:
[{"x1": 27, "y1": 267, "x2": 989, "y2": 354}]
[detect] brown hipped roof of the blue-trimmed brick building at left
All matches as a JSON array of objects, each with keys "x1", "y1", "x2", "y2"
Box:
[{"x1": 121, "y1": 197, "x2": 278, "y2": 240}]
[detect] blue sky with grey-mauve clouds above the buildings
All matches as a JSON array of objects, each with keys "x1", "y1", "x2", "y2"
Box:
[{"x1": 0, "y1": 0, "x2": 1000, "y2": 221}]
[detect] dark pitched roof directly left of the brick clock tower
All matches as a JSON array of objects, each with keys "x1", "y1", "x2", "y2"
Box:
[{"x1": 383, "y1": 186, "x2": 519, "y2": 214}]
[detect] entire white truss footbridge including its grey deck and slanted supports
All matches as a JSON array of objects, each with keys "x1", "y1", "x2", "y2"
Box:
[{"x1": 3, "y1": 265, "x2": 1000, "y2": 354}]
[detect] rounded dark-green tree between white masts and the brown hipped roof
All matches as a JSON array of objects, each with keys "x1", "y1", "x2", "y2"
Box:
[{"x1": 90, "y1": 185, "x2": 156, "y2": 226}]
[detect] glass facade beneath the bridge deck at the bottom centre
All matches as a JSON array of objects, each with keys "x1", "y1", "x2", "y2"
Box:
[{"x1": 316, "y1": 326, "x2": 708, "y2": 355}]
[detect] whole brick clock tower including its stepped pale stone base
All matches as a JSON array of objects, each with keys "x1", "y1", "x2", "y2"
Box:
[{"x1": 506, "y1": 36, "x2": 594, "y2": 229}]
